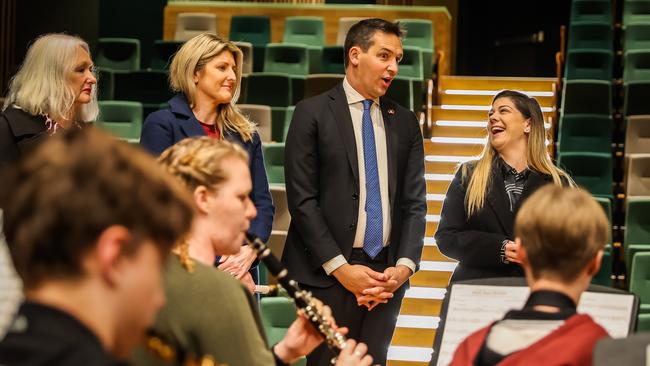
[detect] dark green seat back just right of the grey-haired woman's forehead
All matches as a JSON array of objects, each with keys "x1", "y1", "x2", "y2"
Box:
[{"x1": 95, "y1": 38, "x2": 140, "y2": 71}]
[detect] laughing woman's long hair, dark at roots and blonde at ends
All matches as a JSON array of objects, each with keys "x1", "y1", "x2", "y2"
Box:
[{"x1": 461, "y1": 90, "x2": 575, "y2": 217}]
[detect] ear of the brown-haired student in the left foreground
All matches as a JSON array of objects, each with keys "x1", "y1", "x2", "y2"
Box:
[{"x1": 93, "y1": 225, "x2": 131, "y2": 285}]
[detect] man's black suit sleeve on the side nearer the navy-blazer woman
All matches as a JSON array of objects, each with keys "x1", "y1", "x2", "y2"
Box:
[{"x1": 284, "y1": 102, "x2": 342, "y2": 265}]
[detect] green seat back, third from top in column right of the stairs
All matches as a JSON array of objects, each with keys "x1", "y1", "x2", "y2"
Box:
[{"x1": 564, "y1": 49, "x2": 614, "y2": 81}]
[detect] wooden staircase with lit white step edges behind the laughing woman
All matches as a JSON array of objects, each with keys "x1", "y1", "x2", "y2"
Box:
[{"x1": 388, "y1": 76, "x2": 556, "y2": 366}]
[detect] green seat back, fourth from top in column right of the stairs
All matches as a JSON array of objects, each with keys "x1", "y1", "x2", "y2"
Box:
[{"x1": 562, "y1": 80, "x2": 612, "y2": 115}]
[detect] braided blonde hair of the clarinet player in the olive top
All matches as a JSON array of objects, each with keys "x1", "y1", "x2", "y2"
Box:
[{"x1": 157, "y1": 136, "x2": 248, "y2": 272}]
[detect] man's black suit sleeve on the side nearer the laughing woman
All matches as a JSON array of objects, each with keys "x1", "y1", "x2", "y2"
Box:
[{"x1": 397, "y1": 112, "x2": 427, "y2": 265}]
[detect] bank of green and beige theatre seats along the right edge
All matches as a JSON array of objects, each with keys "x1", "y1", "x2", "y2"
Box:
[{"x1": 557, "y1": 0, "x2": 650, "y2": 330}]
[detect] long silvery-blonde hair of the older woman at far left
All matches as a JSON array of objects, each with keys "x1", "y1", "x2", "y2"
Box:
[{"x1": 3, "y1": 33, "x2": 99, "y2": 122}]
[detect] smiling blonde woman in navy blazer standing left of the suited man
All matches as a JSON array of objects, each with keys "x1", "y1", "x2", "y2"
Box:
[{"x1": 140, "y1": 33, "x2": 274, "y2": 290}]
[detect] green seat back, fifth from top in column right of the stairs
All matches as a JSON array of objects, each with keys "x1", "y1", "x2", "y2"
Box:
[{"x1": 558, "y1": 114, "x2": 613, "y2": 153}]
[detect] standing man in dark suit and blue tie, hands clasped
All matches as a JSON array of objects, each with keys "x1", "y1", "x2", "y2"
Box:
[{"x1": 282, "y1": 19, "x2": 426, "y2": 365}]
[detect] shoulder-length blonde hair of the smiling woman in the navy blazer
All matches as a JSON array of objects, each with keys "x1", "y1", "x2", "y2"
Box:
[{"x1": 169, "y1": 33, "x2": 255, "y2": 141}]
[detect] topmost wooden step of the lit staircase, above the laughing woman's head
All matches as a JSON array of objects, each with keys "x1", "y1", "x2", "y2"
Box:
[{"x1": 438, "y1": 75, "x2": 556, "y2": 91}]
